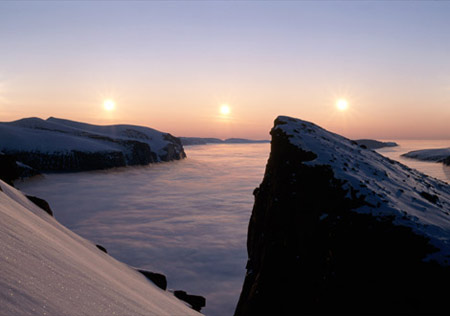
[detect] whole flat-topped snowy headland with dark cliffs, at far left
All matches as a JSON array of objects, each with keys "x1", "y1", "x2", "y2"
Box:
[{"x1": 0, "y1": 118, "x2": 186, "y2": 171}]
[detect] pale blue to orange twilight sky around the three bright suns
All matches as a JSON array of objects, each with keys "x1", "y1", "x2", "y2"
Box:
[{"x1": 0, "y1": 1, "x2": 450, "y2": 139}]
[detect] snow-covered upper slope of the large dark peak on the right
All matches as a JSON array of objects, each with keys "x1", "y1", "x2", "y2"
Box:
[{"x1": 274, "y1": 116, "x2": 450, "y2": 265}]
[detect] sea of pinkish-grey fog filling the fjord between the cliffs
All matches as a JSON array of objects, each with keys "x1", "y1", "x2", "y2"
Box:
[{"x1": 16, "y1": 140, "x2": 450, "y2": 316}]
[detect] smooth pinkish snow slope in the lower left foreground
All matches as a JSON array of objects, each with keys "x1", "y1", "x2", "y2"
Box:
[{"x1": 0, "y1": 180, "x2": 199, "y2": 316}]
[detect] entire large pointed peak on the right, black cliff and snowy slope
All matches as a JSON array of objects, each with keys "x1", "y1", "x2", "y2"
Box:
[{"x1": 236, "y1": 117, "x2": 450, "y2": 315}]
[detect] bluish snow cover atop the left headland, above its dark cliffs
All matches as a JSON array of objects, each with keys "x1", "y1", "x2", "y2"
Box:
[{"x1": 0, "y1": 117, "x2": 178, "y2": 156}]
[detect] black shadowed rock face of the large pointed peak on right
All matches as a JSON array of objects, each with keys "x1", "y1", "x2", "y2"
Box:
[{"x1": 235, "y1": 118, "x2": 450, "y2": 315}]
